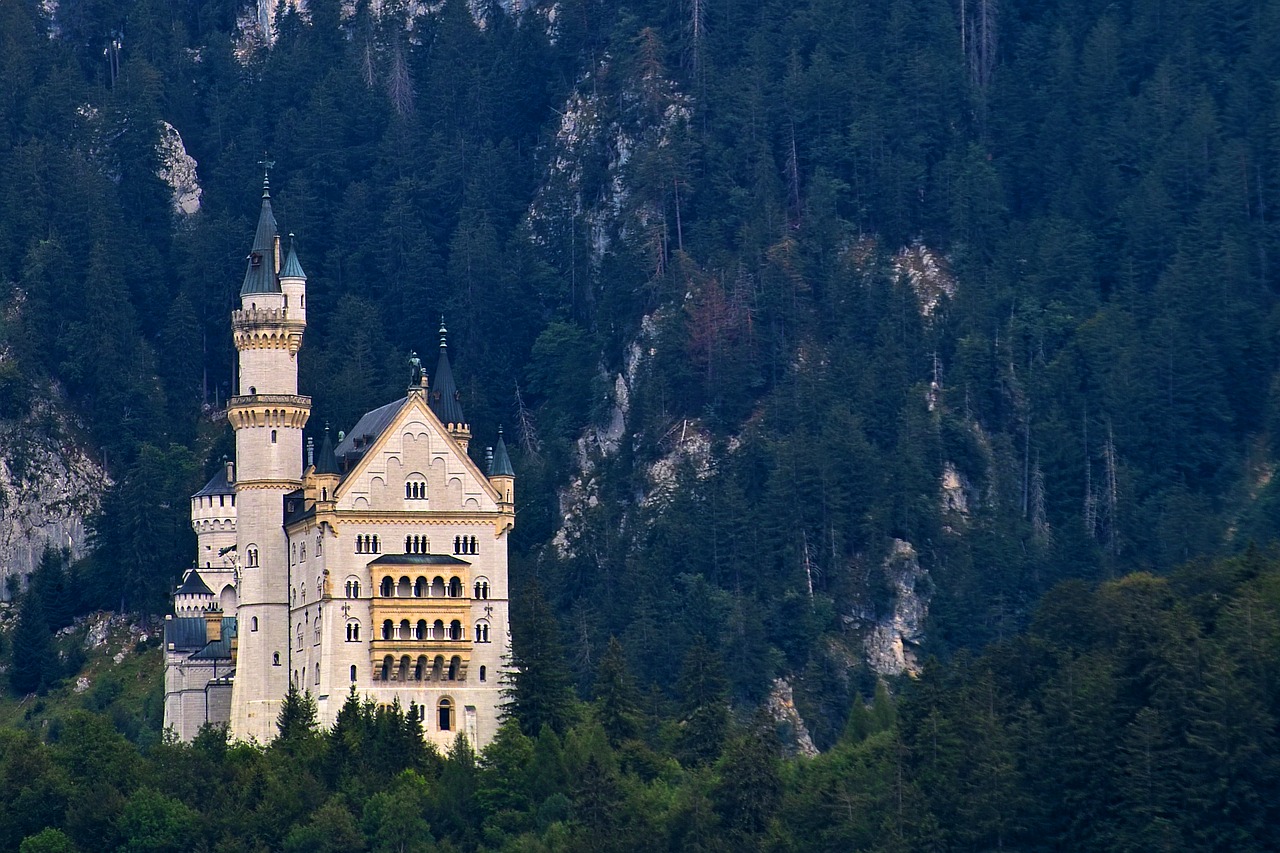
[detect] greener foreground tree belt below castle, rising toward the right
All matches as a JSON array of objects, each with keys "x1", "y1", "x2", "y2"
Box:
[{"x1": 0, "y1": 552, "x2": 1280, "y2": 853}]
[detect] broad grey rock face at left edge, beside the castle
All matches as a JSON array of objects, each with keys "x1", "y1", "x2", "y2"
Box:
[{"x1": 0, "y1": 401, "x2": 110, "y2": 598}]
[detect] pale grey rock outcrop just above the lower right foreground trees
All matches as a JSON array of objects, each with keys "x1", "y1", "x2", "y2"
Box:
[{"x1": 865, "y1": 539, "x2": 929, "y2": 675}]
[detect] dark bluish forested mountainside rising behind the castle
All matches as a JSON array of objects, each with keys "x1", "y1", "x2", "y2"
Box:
[{"x1": 0, "y1": 0, "x2": 1280, "y2": 794}]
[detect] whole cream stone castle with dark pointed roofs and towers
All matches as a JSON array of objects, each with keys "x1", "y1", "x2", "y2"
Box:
[{"x1": 164, "y1": 181, "x2": 515, "y2": 748}]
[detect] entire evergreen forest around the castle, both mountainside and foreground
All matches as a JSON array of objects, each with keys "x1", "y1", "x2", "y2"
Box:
[{"x1": 0, "y1": 0, "x2": 1280, "y2": 853}]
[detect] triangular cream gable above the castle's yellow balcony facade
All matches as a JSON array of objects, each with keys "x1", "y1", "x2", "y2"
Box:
[{"x1": 335, "y1": 394, "x2": 498, "y2": 512}]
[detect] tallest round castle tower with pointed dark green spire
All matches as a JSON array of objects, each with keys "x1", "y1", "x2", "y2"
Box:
[{"x1": 227, "y1": 172, "x2": 311, "y2": 743}]
